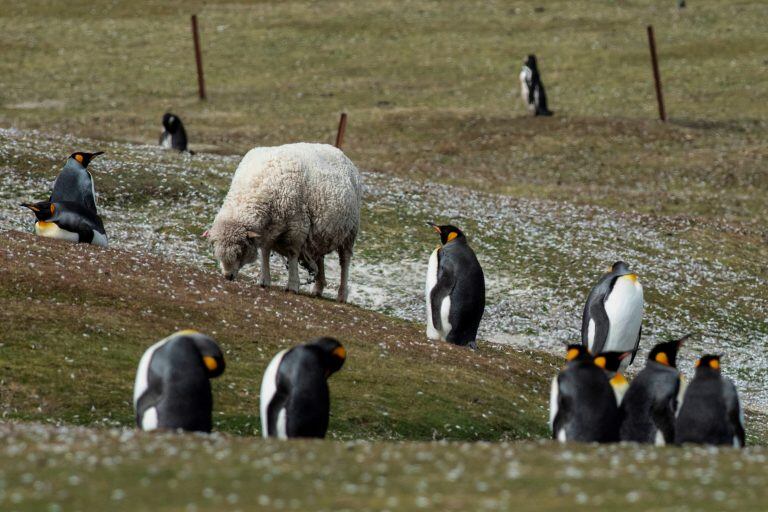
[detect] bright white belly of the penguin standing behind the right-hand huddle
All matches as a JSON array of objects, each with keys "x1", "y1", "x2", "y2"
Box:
[{"x1": 603, "y1": 276, "x2": 643, "y2": 351}]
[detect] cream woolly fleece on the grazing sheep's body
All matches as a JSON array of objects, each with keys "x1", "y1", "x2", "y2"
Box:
[{"x1": 210, "y1": 143, "x2": 362, "y2": 268}]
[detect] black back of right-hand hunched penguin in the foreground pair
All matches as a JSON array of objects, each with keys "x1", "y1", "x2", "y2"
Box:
[{"x1": 267, "y1": 345, "x2": 330, "y2": 438}]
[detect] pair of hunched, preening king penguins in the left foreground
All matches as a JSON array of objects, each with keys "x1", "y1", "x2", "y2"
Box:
[{"x1": 133, "y1": 330, "x2": 347, "y2": 439}]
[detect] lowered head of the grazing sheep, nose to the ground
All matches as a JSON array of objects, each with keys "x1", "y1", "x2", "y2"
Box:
[{"x1": 207, "y1": 222, "x2": 259, "y2": 281}]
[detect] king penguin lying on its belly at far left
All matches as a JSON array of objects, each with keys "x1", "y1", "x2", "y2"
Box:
[{"x1": 21, "y1": 201, "x2": 108, "y2": 247}]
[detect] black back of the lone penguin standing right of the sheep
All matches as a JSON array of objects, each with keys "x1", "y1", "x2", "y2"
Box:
[{"x1": 432, "y1": 239, "x2": 485, "y2": 345}]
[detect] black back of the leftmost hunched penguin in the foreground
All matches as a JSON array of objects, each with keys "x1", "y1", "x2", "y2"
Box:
[{"x1": 136, "y1": 337, "x2": 213, "y2": 432}]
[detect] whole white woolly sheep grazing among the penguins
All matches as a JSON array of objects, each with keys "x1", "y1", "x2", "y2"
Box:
[{"x1": 208, "y1": 143, "x2": 362, "y2": 302}]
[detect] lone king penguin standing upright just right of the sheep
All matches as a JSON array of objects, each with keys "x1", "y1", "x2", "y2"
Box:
[{"x1": 426, "y1": 222, "x2": 485, "y2": 349}]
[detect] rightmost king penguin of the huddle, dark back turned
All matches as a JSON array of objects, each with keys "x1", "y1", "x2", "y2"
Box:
[{"x1": 675, "y1": 355, "x2": 745, "y2": 448}]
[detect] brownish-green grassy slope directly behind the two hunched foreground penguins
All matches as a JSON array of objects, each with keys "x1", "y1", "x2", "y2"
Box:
[{"x1": 0, "y1": 232, "x2": 554, "y2": 440}]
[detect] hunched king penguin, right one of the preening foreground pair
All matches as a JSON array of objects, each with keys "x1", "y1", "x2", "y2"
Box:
[{"x1": 259, "y1": 338, "x2": 347, "y2": 439}]
